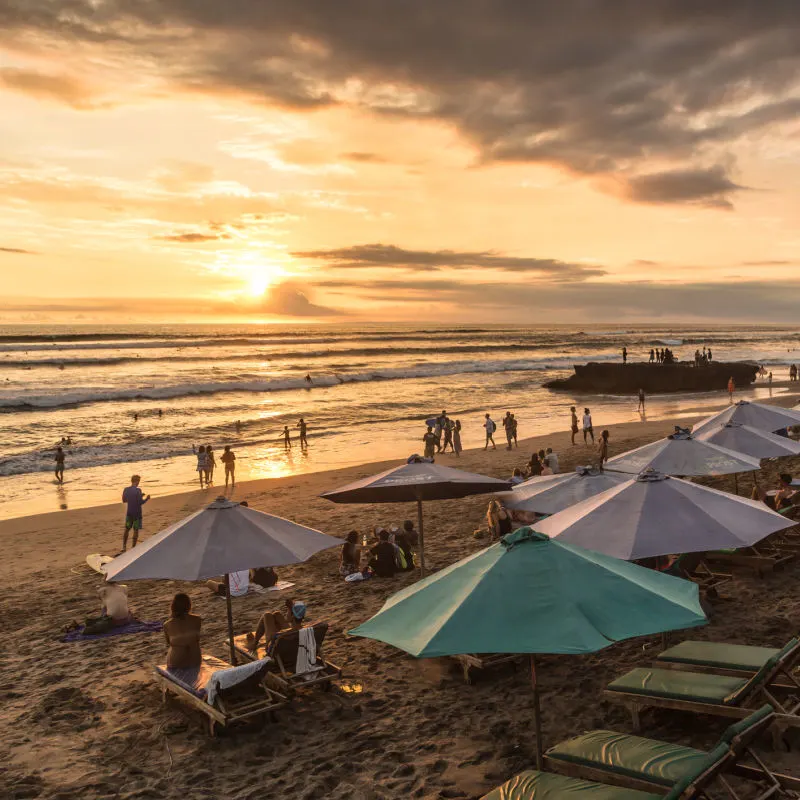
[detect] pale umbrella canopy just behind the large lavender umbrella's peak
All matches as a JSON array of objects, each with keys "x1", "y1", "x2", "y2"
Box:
[{"x1": 606, "y1": 428, "x2": 761, "y2": 476}]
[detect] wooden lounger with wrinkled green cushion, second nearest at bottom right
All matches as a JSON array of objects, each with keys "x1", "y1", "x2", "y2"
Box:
[{"x1": 545, "y1": 705, "x2": 800, "y2": 800}]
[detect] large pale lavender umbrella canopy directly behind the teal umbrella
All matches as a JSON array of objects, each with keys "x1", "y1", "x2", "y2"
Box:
[{"x1": 536, "y1": 471, "x2": 795, "y2": 561}]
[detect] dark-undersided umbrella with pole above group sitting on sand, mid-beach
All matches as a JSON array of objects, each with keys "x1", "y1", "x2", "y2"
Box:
[{"x1": 320, "y1": 460, "x2": 511, "y2": 576}]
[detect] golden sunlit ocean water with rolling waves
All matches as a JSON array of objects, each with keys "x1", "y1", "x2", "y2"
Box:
[{"x1": 0, "y1": 325, "x2": 800, "y2": 518}]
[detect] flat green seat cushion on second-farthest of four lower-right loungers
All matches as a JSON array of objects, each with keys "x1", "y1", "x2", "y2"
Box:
[{"x1": 608, "y1": 667, "x2": 749, "y2": 705}]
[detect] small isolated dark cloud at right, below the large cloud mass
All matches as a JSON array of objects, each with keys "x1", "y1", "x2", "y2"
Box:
[{"x1": 623, "y1": 167, "x2": 747, "y2": 209}]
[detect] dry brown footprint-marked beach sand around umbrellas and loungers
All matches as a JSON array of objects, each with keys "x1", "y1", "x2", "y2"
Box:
[{"x1": 0, "y1": 396, "x2": 800, "y2": 800}]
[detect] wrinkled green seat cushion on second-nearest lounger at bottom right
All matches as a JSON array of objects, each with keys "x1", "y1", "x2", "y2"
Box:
[{"x1": 547, "y1": 730, "x2": 708, "y2": 787}]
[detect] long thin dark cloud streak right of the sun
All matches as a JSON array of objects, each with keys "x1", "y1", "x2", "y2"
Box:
[{"x1": 292, "y1": 244, "x2": 606, "y2": 280}]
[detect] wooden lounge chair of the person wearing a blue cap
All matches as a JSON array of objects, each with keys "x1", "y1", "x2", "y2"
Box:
[{"x1": 227, "y1": 622, "x2": 342, "y2": 695}]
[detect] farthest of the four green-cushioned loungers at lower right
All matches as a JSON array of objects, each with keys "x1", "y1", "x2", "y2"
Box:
[{"x1": 654, "y1": 640, "x2": 800, "y2": 690}]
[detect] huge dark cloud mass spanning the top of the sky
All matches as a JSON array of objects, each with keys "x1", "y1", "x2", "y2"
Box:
[{"x1": 0, "y1": 0, "x2": 800, "y2": 208}]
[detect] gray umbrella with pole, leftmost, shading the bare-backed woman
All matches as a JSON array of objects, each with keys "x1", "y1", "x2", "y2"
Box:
[{"x1": 106, "y1": 497, "x2": 342, "y2": 664}]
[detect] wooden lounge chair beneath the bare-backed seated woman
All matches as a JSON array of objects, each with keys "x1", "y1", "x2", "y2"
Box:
[{"x1": 154, "y1": 656, "x2": 287, "y2": 736}]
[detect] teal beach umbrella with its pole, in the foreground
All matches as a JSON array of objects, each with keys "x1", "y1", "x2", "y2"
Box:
[{"x1": 350, "y1": 527, "x2": 707, "y2": 768}]
